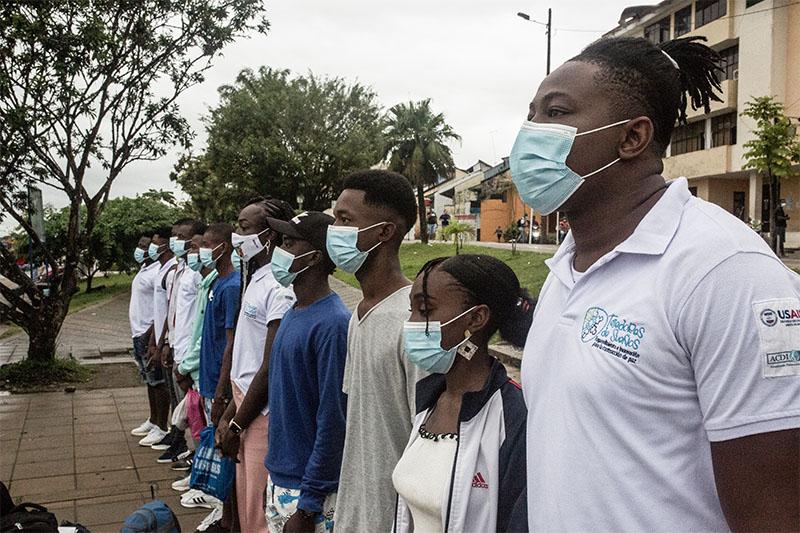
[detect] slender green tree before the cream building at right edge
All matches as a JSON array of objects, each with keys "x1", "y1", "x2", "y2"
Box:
[{"x1": 742, "y1": 96, "x2": 800, "y2": 252}]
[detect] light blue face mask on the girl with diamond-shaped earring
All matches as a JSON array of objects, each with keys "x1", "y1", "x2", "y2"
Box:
[{"x1": 403, "y1": 306, "x2": 476, "y2": 374}]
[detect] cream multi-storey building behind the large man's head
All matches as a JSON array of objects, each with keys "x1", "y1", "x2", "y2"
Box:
[{"x1": 605, "y1": 0, "x2": 800, "y2": 246}]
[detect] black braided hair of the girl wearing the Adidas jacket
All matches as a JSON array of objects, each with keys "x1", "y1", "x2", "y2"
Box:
[{"x1": 417, "y1": 254, "x2": 536, "y2": 348}]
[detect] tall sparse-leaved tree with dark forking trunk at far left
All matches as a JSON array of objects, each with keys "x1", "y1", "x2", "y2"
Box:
[{"x1": 0, "y1": 0, "x2": 267, "y2": 359}]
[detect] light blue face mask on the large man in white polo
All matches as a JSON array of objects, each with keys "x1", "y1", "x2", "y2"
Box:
[{"x1": 508, "y1": 120, "x2": 629, "y2": 215}]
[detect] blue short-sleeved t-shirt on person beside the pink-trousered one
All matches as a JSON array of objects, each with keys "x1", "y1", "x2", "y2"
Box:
[{"x1": 200, "y1": 272, "x2": 241, "y2": 398}]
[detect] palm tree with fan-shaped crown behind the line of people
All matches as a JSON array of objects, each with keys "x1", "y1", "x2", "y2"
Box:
[{"x1": 383, "y1": 99, "x2": 461, "y2": 244}]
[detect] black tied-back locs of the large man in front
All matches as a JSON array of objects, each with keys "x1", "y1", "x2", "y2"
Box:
[{"x1": 570, "y1": 36, "x2": 722, "y2": 155}]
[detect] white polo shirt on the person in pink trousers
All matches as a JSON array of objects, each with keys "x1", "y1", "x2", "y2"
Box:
[{"x1": 231, "y1": 263, "x2": 295, "y2": 415}]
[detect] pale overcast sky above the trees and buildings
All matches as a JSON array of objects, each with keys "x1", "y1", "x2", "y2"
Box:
[{"x1": 4, "y1": 0, "x2": 640, "y2": 229}]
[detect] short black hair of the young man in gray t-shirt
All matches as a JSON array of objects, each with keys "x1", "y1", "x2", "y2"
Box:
[{"x1": 343, "y1": 169, "x2": 417, "y2": 234}]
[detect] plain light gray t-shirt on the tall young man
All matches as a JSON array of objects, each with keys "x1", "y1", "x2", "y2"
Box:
[{"x1": 334, "y1": 286, "x2": 424, "y2": 532}]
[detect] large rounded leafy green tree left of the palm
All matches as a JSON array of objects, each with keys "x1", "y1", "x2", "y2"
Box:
[{"x1": 171, "y1": 67, "x2": 381, "y2": 215}]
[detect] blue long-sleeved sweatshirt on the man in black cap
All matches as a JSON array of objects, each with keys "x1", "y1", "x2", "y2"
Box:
[{"x1": 264, "y1": 293, "x2": 350, "y2": 512}]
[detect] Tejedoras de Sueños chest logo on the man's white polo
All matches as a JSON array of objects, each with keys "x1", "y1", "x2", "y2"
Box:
[{"x1": 581, "y1": 307, "x2": 645, "y2": 364}]
